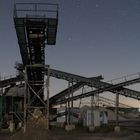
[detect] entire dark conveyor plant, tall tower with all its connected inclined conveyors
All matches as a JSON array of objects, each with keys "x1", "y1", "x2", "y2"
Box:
[{"x1": 0, "y1": 3, "x2": 140, "y2": 130}]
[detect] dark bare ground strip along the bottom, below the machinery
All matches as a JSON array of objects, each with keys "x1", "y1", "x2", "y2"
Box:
[{"x1": 0, "y1": 127, "x2": 140, "y2": 140}]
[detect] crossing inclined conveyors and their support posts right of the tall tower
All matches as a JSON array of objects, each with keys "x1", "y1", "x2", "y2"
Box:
[{"x1": 46, "y1": 69, "x2": 140, "y2": 125}]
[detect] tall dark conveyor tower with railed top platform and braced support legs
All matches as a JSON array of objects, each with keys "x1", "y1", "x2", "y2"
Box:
[{"x1": 14, "y1": 3, "x2": 58, "y2": 131}]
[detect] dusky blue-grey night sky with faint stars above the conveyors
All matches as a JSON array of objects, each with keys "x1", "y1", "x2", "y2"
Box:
[{"x1": 0, "y1": 0, "x2": 140, "y2": 105}]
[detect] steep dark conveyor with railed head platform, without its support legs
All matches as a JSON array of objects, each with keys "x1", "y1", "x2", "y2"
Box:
[{"x1": 14, "y1": 3, "x2": 58, "y2": 105}]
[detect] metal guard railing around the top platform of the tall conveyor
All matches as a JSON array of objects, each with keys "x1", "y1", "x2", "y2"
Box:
[{"x1": 14, "y1": 3, "x2": 59, "y2": 18}]
